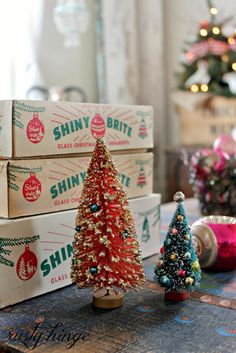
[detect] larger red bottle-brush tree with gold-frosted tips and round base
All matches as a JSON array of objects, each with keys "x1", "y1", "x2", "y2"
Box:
[{"x1": 71, "y1": 139, "x2": 145, "y2": 308}]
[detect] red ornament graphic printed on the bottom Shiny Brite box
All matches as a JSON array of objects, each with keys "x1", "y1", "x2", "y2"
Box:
[{"x1": 16, "y1": 244, "x2": 38, "y2": 281}]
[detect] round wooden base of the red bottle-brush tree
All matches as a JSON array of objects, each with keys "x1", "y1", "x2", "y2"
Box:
[{"x1": 93, "y1": 289, "x2": 124, "y2": 309}]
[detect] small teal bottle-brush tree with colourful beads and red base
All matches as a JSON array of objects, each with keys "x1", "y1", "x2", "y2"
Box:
[{"x1": 154, "y1": 191, "x2": 201, "y2": 301}]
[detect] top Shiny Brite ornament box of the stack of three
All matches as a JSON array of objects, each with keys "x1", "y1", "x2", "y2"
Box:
[{"x1": 0, "y1": 100, "x2": 153, "y2": 158}]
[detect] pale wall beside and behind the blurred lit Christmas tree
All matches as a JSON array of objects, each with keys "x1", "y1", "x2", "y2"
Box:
[{"x1": 163, "y1": 0, "x2": 236, "y2": 145}]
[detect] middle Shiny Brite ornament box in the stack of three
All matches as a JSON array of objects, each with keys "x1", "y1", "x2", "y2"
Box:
[{"x1": 0, "y1": 153, "x2": 153, "y2": 218}]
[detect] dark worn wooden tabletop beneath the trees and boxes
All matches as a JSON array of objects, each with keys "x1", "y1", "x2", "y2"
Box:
[{"x1": 0, "y1": 199, "x2": 236, "y2": 353}]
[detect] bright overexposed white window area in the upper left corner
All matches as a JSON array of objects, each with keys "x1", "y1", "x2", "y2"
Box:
[{"x1": 0, "y1": 0, "x2": 42, "y2": 99}]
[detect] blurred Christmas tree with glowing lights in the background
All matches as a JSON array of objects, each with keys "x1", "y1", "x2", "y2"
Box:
[{"x1": 177, "y1": 0, "x2": 236, "y2": 97}]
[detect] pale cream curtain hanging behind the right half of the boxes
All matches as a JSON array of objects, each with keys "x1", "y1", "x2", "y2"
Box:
[{"x1": 97, "y1": 0, "x2": 166, "y2": 193}]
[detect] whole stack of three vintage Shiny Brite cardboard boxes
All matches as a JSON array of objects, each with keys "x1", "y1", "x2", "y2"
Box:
[{"x1": 0, "y1": 101, "x2": 160, "y2": 307}]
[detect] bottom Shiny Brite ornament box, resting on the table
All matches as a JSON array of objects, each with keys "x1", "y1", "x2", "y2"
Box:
[{"x1": 0, "y1": 194, "x2": 161, "y2": 308}]
